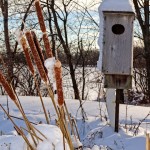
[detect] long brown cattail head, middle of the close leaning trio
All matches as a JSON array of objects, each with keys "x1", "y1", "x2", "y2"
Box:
[{"x1": 25, "y1": 31, "x2": 47, "y2": 82}]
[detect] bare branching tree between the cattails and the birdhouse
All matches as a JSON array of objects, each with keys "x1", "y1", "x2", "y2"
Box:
[{"x1": 43, "y1": 0, "x2": 98, "y2": 99}]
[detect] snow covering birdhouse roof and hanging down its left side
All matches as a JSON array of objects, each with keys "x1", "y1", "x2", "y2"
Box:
[{"x1": 97, "y1": 0, "x2": 135, "y2": 72}]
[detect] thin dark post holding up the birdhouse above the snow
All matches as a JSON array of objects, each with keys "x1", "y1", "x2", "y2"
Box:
[{"x1": 115, "y1": 89, "x2": 122, "y2": 132}]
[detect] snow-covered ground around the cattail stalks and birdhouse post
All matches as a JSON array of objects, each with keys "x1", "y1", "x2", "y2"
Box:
[{"x1": 0, "y1": 96, "x2": 150, "y2": 150}]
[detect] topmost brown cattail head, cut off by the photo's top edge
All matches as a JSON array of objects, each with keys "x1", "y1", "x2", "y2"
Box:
[{"x1": 35, "y1": 0, "x2": 46, "y2": 33}]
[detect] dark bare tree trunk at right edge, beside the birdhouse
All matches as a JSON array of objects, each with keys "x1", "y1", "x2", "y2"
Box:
[{"x1": 133, "y1": 0, "x2": 150, "y2": 100}]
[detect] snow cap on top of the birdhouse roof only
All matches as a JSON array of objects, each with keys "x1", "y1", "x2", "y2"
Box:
[{"x1": 99, "y1": 0, "x2": 135, "y2": 12}]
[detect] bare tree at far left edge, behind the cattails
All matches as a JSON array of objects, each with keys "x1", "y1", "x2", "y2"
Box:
[{"x1": 0, "y1": 0, "x2": 34, "y2": 88}]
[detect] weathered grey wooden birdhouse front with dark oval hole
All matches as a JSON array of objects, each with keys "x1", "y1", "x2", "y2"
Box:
[{"x1": 102, "y1": 12, "x2": 134, "y2": 75}]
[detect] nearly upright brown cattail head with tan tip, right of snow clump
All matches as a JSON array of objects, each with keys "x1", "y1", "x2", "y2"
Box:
[{"x1": 54, "y1": 60, "x2": 64, "y2": 106}]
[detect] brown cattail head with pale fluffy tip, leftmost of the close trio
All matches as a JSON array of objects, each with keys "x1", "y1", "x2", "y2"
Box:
[{"x1": 20, "y1": 36, "x2": 34, "y2": 75}]
